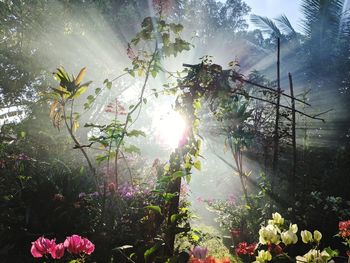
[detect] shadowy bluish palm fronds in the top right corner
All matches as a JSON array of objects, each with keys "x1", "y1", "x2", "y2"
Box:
[{"x1": 301, "y1": 0, "x2": 350, "y2": 78}]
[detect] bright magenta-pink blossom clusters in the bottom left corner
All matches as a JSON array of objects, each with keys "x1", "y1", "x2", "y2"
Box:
[{"x1": 30, "y1": 235, "x2": 95, "y2": 262}]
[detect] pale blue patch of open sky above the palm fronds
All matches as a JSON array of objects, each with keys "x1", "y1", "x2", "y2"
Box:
[{"x1": 244, "y1": 0, "x2": 302, "y2": 31}]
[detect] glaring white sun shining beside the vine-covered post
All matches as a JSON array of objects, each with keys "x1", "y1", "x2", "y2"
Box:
[{"x1": 153, "y1": 110, "x2": 186, "y2": 149}]
